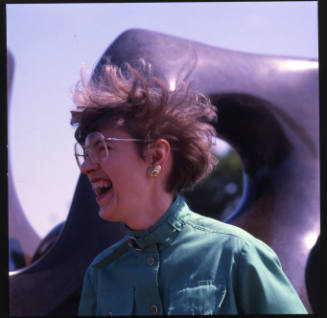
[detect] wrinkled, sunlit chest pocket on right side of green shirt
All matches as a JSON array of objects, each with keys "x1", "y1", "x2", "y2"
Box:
[{"x1": 167, "y1": 281, "x2": 226, "y2": 315}]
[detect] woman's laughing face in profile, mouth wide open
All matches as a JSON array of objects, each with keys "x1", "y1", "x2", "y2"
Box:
[{"x1": 81, "y1": 128, "x2": 159, "y2": 224}]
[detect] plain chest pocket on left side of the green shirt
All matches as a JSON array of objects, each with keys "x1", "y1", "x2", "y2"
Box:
[{"x1": 96, "y1": 288, "x2": 134, "y2": 316}]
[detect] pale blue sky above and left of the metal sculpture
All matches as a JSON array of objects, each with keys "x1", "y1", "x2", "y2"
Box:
[{"x1": 6, "y1": 1, "x2": 318, "y2": 236}]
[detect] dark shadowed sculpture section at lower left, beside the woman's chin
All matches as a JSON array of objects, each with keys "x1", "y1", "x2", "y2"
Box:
[{"x1": 9, "y1": 175, "x2": 123, "y2": 316}]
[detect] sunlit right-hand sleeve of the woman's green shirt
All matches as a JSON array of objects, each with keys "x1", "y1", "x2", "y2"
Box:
[{"x1": 237, "y1": 240, "x2": 307, "y2": 314}]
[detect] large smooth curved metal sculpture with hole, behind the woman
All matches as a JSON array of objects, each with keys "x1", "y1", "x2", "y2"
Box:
[{"x1": 9, "y1": 30, "x2": 320, "y2": 316}]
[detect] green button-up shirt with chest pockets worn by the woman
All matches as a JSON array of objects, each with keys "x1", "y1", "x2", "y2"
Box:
[{"x1": 78, "y1": 196, "x2": 307, "y2": 316}]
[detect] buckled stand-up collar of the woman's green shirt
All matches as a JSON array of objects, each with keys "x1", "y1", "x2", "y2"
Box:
[{"x1": 125, "y1": 195, "x2": 189, "y2": 250}]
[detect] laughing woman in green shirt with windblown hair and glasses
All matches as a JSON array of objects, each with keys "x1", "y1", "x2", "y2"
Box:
[{"x1": 72, "y1": 60, "x2": 306, "y2": 315}]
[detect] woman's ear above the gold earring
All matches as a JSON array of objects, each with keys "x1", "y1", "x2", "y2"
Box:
[{"x1": 146, "y1": 138, "x2": 170, "y2": 168}]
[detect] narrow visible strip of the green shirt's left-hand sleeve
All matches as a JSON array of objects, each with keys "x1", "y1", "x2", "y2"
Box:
[{"x1": 78, "y1": 270, "x2": 96, "y2": 316}]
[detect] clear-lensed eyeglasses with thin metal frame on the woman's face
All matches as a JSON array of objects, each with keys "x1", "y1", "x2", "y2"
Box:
[{"x1": 74, "y1": 132, "x2": 142, "y2": 169}]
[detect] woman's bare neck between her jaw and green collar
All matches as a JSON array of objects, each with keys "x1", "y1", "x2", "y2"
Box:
[{"x1": 125, "y1": 192, "x2": 175, "y2": 230}]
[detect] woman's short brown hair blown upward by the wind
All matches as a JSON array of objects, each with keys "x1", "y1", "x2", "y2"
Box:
[{"x1": 71, "y1": 63, "x2": 217, "y2": 192}]
